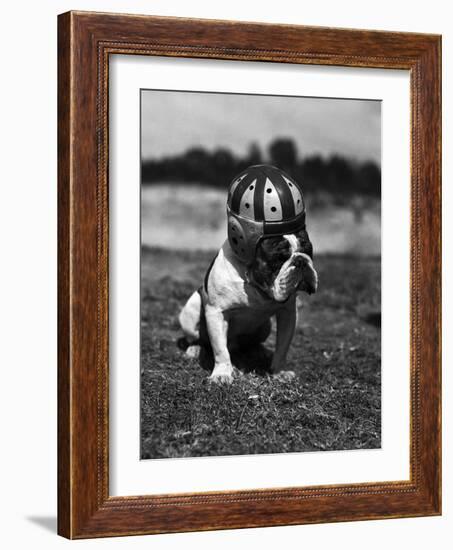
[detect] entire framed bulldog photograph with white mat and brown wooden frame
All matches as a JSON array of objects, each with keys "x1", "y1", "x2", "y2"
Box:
[{"x1": 58, "y1": 12, "x2": 441, "y2": 538}]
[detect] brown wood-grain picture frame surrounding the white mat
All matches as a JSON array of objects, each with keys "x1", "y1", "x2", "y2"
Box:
[{"x1": 58, "y1": 12, "x2": 441, "y2": 538}]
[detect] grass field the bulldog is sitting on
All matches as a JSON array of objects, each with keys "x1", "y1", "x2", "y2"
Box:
[{"x1": 141, "y1": 247, "x2": 381, "y2": 458}]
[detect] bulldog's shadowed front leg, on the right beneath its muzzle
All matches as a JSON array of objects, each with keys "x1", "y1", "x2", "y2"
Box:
[{"x1": 271, "y1": 296, "x2": 297, "y2": 380}]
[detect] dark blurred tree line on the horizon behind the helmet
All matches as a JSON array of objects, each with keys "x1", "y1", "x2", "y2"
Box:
[{"x1": 142, "y1": 138, "x2": 381, "y2": 203}]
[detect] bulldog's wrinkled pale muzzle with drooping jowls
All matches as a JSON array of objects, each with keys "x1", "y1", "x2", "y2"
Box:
[{"x1": 271, "y1": 252, "x2": 318, "y2": 302}]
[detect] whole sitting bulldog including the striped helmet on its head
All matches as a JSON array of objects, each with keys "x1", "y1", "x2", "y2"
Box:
[{"x1": 179, "y1": 165, "x2": 318, "y2": 383}]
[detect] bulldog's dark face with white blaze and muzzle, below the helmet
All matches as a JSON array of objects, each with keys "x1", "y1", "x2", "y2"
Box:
[{"x1": 249, "y1": 230, "x2": 318, "y2": 302}]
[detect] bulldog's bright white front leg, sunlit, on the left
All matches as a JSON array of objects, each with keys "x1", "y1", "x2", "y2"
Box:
[{"x1": 205, "y1": 305, "x2": 233, "y2": 384}]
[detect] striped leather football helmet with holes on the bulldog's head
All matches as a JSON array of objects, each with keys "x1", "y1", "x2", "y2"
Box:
[{"x1": 227, "y1": 164, "x2": 305, "y2": 265}]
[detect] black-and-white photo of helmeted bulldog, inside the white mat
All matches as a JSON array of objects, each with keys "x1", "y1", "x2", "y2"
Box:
[{"x1": 140, "y1": 89, "x2": 381, "y2": 459}]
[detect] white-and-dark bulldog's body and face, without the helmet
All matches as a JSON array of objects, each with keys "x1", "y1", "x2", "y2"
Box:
[{"x1": 179, "y1": 229, "x2": 318, "y2": 384}]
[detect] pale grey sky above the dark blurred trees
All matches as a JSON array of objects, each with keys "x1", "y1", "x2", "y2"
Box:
[{"x1": 142, "y1": 90, "x2": 381, "y2": 164}]
